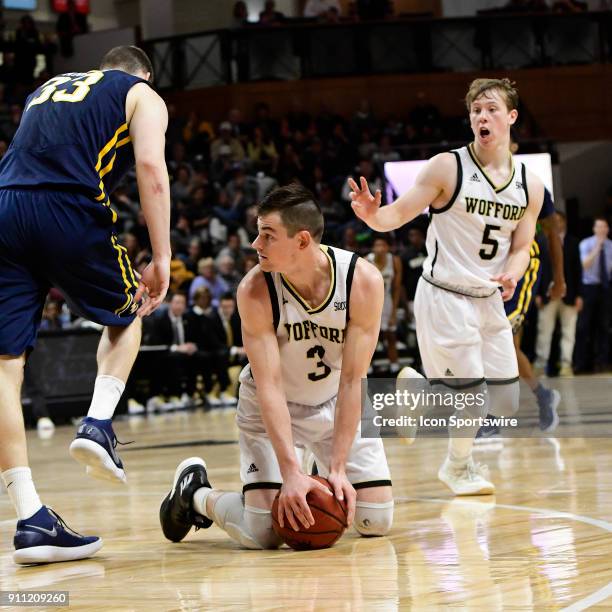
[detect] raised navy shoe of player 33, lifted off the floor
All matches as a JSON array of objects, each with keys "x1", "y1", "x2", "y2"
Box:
[{"x1": 70, "y1": 417, "x2": 126, "y2": 483}]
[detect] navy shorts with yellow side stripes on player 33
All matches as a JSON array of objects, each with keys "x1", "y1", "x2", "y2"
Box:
[{"x1": 0, "y1": 189, "x2": 138, "y2": 355}]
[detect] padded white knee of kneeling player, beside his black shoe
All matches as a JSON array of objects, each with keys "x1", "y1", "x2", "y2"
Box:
[{"x1": 213, "y1": 493, "x2": 282, "y2": 550}]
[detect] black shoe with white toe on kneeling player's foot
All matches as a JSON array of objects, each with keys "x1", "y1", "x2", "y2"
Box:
[{"x1": 159, "y1": 457, "x2": 213, "y2": 542}]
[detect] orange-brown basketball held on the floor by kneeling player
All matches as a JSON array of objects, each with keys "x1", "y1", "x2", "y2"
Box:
[{"x1": 272, "y1": 476, "x2": 347, "y2": 550}]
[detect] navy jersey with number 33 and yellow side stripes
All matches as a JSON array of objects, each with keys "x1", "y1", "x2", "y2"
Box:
[{"x1": 0, "y1": 70, "x2": 146, "y2": 206}]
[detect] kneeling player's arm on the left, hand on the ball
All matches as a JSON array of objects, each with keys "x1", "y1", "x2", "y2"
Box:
[{"x1": 237, "y1": 266, "x2": 329, "y2": 531}]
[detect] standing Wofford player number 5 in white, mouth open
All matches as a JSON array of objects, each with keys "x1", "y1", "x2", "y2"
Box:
[{"x1": 350, "y1": 79, "x2": 544, "y2": 495}]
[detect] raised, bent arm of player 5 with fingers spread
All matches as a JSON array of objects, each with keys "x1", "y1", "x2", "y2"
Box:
[{"x1": 348, "y1": 153, "x2": 457, "y2": 232}]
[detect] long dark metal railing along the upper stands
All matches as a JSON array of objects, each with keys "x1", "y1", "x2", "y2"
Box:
[{"x1": 145, "y1": 11, "x2": 612, "y2": 89}]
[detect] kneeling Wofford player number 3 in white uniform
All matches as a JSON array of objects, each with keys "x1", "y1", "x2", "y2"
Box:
[{"x1": 160, "y1": 184, "x2": 393, "y2": 549}]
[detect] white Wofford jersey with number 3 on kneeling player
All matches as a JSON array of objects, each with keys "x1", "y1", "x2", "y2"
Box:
[{"x1": 240, "y1": 245, "x2": 358, "y2": 406}]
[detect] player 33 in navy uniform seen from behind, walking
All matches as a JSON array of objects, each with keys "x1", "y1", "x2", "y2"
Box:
[{"x1": 0, "y1": 47, "x2": 170, "y2": 563}]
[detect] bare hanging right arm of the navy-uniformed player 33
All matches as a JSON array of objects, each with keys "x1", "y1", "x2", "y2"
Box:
[{"x1": 126, "y1": 83, "x2": 171, "y2": 316}]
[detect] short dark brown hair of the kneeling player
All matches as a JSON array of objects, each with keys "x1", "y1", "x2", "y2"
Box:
[{"x1": 257, "y1": 183, "x2": 324, "y2": 242}]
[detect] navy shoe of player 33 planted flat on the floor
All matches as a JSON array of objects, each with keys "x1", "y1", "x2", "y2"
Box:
[{"x1": 13, "y1": 506, "x2": 102, "y2": 565}]
